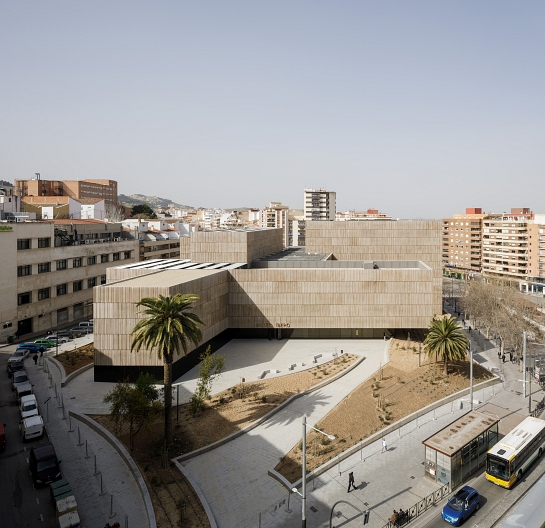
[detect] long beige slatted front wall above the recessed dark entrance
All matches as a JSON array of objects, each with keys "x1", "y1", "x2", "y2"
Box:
[{"x1": 229, "y1": 268, "x2": 434, "y2": 328}]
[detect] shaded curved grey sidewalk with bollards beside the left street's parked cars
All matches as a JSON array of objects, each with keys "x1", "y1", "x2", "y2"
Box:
[{"x1": 27, "y1": 354, "x2": 149, "y2": 528}]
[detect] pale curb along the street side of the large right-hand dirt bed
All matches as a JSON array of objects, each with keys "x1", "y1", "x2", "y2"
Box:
[{"x1": 267, "y1": 376, "x2": 501, "y2": 491}]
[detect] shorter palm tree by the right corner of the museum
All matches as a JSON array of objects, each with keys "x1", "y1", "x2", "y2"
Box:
[{"x1": 424, "y1": 317, "x2": 469, "y2": 376}]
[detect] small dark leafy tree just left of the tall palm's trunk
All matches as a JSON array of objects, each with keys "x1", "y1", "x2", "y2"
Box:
[{"x1": 104, "y1": 372, "x2": 163, "y2": 453}]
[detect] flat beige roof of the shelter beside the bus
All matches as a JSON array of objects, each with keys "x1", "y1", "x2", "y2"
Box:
[{"x1": 422, "y1": 411, "x2": 500, "y2": 456}]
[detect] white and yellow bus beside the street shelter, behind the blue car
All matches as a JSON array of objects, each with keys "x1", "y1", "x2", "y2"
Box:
[{"x1": 486, "y1": 416, "x2": 545, "y2": 489}]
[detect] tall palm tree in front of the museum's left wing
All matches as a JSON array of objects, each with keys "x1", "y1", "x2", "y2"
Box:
[{"x1": 131, "y1": 293, "x2": 204, "y2": 446}]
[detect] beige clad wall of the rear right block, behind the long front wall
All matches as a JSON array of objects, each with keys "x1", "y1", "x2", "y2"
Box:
[{"x1": 306, "y1": 220, "x2": 442, "y2": 314}]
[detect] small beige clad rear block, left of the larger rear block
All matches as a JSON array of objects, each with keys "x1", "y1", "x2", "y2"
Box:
[{"x1": 191, "y1": 229, "x2": 284, "y2": 262}]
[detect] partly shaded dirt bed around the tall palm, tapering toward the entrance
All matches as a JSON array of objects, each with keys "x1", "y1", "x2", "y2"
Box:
[{"x1": 91, "y1": 354, "x2": 359, "y2": 528}]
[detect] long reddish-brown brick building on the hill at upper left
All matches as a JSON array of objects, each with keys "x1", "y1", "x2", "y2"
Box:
[{"x1": 14, "y1": 180, "x2": 117, "y2": 205}]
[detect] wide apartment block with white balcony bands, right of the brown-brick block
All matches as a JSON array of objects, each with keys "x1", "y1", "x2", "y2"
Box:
[{"x1": 482, "y1": 207, "x2": 533, "y2": 281}]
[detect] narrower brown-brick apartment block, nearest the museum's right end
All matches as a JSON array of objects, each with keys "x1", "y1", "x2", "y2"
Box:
[{"x1": 441, "y1": 207, "x2": 487, "y2": 278}]
